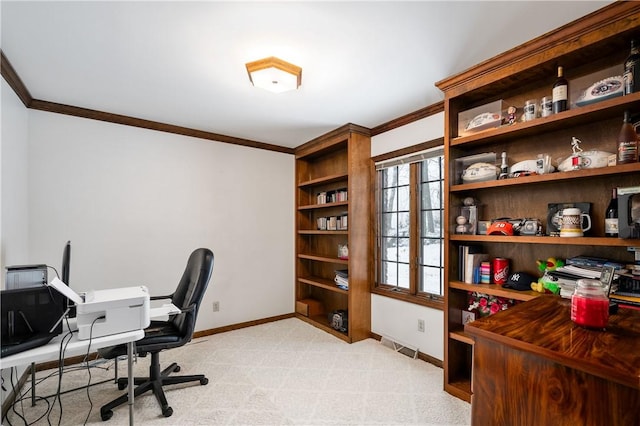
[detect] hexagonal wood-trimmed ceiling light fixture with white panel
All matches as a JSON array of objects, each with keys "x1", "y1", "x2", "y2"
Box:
[{"x1": 246, "y1": 56, "x2": 302, "y2": 93}]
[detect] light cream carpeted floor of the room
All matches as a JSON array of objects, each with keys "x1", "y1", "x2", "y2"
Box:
[{"x1": 3, "y1": 318, "x2": 470, "y2": 426}]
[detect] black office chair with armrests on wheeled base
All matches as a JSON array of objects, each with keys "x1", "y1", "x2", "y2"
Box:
[{"x1": 98, "y1": 248, "x2": 213, "y2": 420}]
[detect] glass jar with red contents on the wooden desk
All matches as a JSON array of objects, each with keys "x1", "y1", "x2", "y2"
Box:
[{"x1": 571, "y1": 279, "x2": 609, "y2": 329}]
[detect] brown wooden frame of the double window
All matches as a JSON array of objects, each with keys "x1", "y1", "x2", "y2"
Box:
[{"x1": 371, "y1": 138, "x2": 447, "y2": 310}]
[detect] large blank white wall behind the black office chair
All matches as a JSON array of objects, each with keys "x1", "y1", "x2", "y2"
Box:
[{"x1": 23, "y1": 111, "x2": 294, "y2": 330}]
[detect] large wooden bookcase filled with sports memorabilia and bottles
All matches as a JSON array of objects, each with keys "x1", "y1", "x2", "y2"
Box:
[{"x1": 436, "y1": 2, "x2": 640, "y2": 401}]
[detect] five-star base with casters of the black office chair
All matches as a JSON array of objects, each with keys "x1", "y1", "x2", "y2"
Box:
[{"x1": 100, "y1": 352, "x2": 209, "y2": 421}]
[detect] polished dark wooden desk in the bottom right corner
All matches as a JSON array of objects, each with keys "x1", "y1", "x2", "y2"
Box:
[{"x1": 465, "y1": 296, "x2": 640, "y2": 426}]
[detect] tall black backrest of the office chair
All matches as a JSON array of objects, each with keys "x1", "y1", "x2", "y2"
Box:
[{"x1": 171, "y1": 248, "x2": 213, "y2": 332}]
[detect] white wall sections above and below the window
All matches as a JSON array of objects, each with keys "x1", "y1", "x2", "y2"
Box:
[{"x1": 371, "y1": 113, "x2": 444, "y2": 360}]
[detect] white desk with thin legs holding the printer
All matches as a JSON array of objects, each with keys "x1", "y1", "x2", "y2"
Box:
[{"x1": 0, "y1": 318, "x2": 144, "y2": 425}]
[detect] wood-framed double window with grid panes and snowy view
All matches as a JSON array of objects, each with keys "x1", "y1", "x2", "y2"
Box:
[{"x1": 375, "y1": 147, "x2": 444, "y2": 304}]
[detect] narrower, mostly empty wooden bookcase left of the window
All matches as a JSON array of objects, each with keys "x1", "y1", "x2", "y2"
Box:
[{"x1": 295, "y1": 124, "x2": 373, "y2": 343}]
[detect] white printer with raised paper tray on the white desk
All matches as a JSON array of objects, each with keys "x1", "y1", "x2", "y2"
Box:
[{"x1": 50, "y1": 278, "x2": 151, "y2": 340}]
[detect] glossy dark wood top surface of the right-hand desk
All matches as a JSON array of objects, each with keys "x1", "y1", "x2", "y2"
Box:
[{"x1": 465, "y1": 296, "x2": 640, "y2": 389}]
